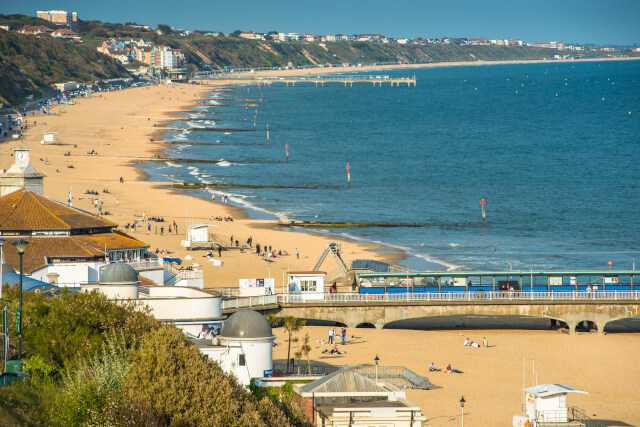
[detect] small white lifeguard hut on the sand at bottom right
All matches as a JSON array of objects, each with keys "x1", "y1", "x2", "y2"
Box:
[{"x1": 513, "y1": 384, "x2": 589, "y2": 427}]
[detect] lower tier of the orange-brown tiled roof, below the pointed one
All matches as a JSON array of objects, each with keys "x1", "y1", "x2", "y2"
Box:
[{"x1": 4, "y1": 233, "x2": 149, "y2": 274}]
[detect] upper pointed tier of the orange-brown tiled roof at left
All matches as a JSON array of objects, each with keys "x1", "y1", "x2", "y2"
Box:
[{"x1": 0, "y1": 190, "x2": 116, "y2": 231}]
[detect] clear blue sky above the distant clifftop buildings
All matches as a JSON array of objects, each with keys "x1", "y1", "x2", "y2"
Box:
[{"x1": 5, "y1": 0, "x2": 640, "y2": 44}]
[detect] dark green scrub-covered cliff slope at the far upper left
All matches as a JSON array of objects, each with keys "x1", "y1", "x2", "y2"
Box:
[{"x1": 0, "y1": 31, "x2": 127, "y2": 104}]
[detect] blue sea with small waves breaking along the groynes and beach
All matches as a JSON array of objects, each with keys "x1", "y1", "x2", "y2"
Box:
[{"x1": 155, "y1": 61, "x2": 640, "y2": 270}]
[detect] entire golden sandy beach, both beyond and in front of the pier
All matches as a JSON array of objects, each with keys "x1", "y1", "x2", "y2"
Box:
[{"x1": 5, "y1": 58, "x2": 640, "y2": 427}]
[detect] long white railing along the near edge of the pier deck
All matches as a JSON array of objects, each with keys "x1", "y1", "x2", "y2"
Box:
[{"x1": 278, "y1": 290, "x2": 640, "y2": 304}]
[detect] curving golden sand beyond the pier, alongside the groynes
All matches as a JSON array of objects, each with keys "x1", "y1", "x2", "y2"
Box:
[{"x1": 5, "y1": 84, "x2": 420, "y2": 291}]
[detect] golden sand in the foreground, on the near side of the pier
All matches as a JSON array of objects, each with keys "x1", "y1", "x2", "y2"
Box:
[{"x1": 274, "y1": 326, "x2": 640, "y2": 427}]
